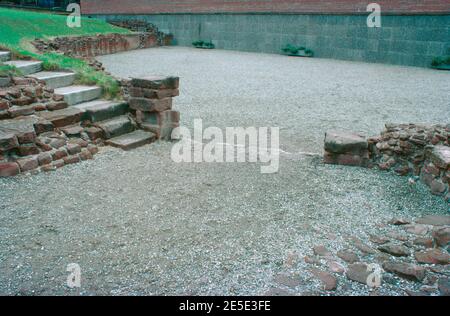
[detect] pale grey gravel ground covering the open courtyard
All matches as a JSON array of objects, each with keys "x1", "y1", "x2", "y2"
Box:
[{"x1": 0, "y1": 48, "x2": 450, "y2": 295}]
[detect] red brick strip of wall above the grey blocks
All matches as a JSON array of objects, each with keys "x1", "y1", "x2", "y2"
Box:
[{"x1": 81, "y1": 0, "x2": 450, "y2": 14}]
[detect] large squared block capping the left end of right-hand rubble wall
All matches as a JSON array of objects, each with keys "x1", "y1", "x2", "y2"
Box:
[{"x1": 325, "y1": 132, "x2": 368, "y2": 154}]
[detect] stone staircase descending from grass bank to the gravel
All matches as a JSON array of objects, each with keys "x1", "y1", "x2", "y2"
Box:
[{"x1": 0, "y1": 52, "x2": 156, "y2": 150}]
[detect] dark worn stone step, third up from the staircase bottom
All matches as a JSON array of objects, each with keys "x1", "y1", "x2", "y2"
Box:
[{"x1": 74, "y1": 100, "x2": 129, "y2": 123}]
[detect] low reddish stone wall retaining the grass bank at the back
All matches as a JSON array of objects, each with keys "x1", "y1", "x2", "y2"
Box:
[{"x1": 33, "y1": 32, "x2": 160, "y2": 57}]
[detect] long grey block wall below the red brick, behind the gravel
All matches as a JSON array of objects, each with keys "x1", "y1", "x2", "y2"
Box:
[{"x1": 90, "y1": 14, "x2": 450, "y2": 67}]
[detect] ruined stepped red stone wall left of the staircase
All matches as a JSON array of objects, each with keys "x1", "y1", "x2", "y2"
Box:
[{"x1": 0, "y1": 78, "x2": 101, "y2": 177}]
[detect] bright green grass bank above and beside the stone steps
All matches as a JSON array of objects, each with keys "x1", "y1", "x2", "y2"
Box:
[{"x1": 0, "y1": 8, "x2": 130, "y2": 98}]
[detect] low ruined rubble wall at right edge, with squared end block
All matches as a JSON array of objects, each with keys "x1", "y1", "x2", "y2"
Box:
[{"x1": 324, "y1": 124, "x2": 450, "y2": 202}]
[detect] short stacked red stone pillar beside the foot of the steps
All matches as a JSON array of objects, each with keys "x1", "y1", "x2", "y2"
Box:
[{"x1": 128, "y1": 77, "x2": 180, "y2": 140}]
